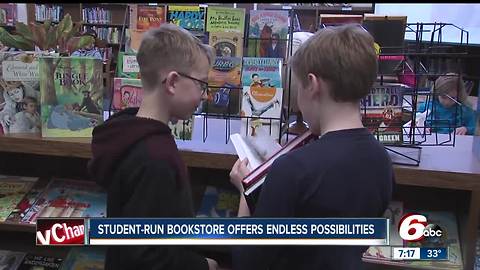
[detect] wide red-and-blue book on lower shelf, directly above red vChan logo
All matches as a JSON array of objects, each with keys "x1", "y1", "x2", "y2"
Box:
[{"x1": 24, "y1": 178, "x2": 107, "y2": 224}]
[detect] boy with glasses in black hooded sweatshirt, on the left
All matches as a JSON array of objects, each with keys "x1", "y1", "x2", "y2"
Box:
[{"x1": 89, "y1": 24, "x2": 217, "y2": 270}]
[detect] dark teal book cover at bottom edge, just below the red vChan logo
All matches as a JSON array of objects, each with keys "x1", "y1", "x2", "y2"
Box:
[{"x1": 60, "y1": 246, "x2": 106, "y2": 270}]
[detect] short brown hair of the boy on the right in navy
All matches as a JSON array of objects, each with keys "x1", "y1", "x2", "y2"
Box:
[{"x1": 290, "y1": 24, "x2": 377, "y2": 102}]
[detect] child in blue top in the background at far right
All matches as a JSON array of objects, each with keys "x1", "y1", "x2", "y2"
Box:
[{"x1": 418, "y1": 73, "x2": 475, "y2": 135}]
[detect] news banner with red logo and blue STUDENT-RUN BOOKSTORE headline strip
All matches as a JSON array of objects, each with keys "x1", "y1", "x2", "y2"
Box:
[{"x1": 36, "y1": 218, "x2": 389, "y2": 246}]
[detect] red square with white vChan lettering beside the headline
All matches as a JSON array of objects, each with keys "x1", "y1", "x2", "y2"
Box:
[{"x1": 36, "y1": 218, "x2": 85, "y2": 246}]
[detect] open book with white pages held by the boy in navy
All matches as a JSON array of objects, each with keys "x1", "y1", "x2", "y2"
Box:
[{"x1": 230, "y1": 131, "x2": 318, "y2": 211}]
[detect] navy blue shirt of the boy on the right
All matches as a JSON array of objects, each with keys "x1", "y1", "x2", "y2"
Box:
[{"x1": 233, "y1": 128, "x2": 394, "y2": 270}]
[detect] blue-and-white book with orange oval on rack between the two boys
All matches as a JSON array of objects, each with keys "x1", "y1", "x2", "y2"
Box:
[{"x1": 240, "y1": 57, "x2": 283, "y2": 139}]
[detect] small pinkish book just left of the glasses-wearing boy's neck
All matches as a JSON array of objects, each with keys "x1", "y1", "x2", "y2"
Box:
[{"x1": 112, "y1": 78, "x2": 143, "y2": 110}]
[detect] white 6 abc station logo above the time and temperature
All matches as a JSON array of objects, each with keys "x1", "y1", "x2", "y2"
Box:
[{"x1": 398, "y1": 213, "x2": 446, "y2": 242}]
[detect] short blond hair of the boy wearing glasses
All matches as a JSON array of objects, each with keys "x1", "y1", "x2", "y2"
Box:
[{"x1": 137, "y1": 23, "x2": 214, "y2": 89}]
